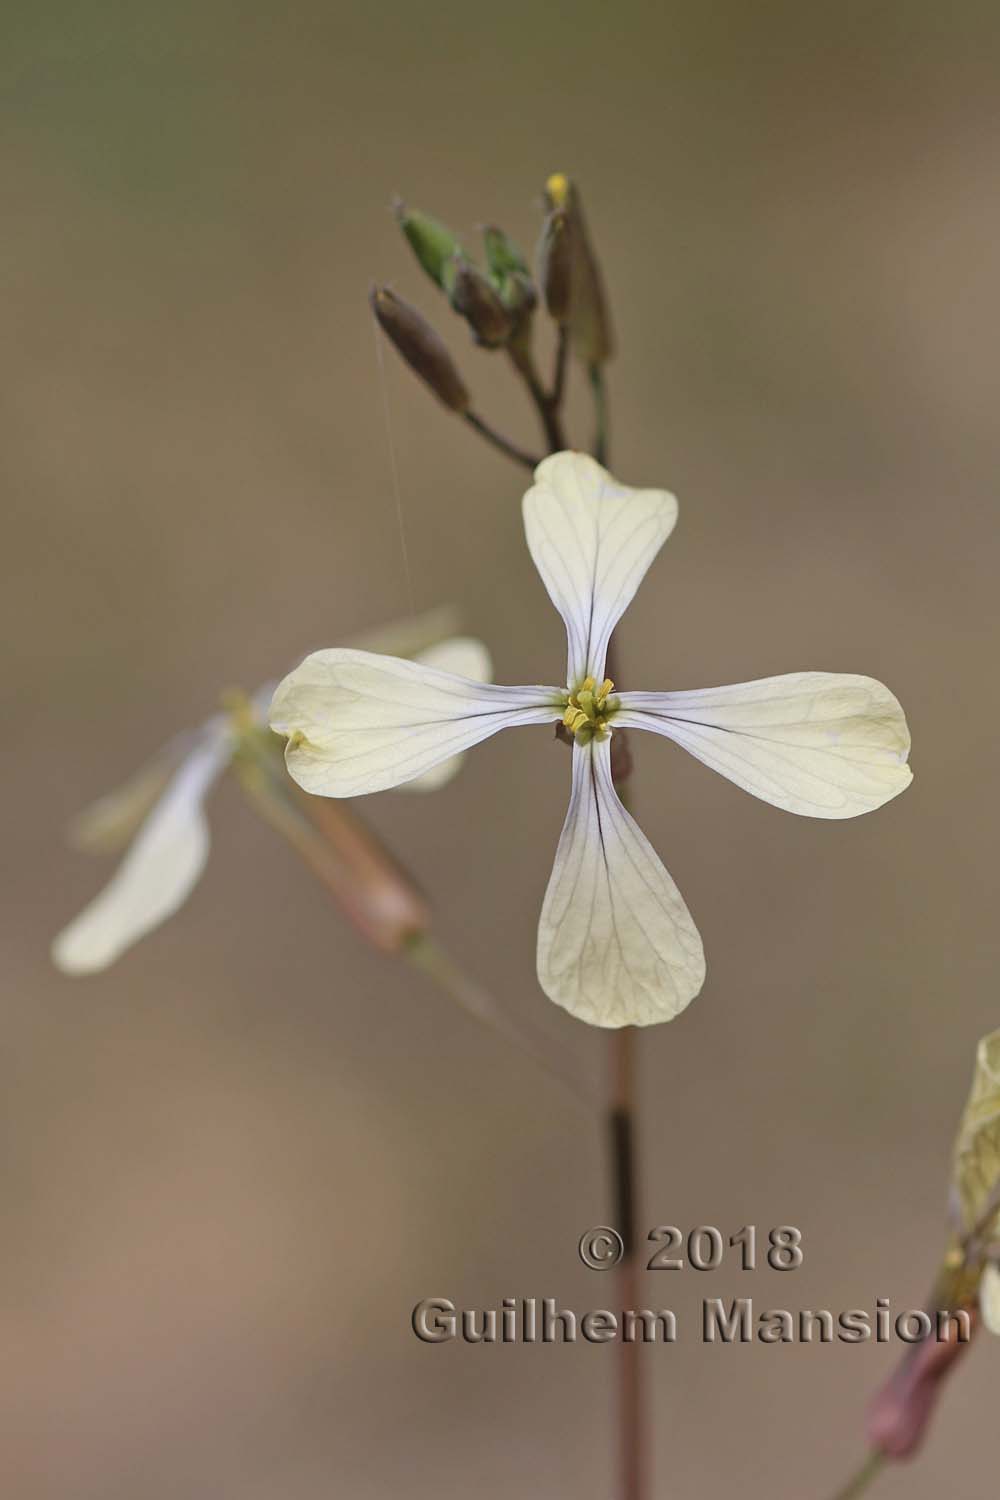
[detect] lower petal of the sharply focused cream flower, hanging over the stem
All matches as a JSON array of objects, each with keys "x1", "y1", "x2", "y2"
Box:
[{"x1": 538, "y1": 740, "x2": 705, "y2": 1026}]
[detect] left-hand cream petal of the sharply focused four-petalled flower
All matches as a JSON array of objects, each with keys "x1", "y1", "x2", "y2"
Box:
[{"x1": 270, "y1": 648, "x2": 565, "y2": 797}]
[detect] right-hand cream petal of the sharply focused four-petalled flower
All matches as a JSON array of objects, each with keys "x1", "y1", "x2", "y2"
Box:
[{"x1": 615, "y1": 672, "x2": 913, "y2": 818}]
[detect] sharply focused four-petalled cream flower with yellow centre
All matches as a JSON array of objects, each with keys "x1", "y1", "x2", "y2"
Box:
[{"x1": 270, "y1": 453, "x2": 910, "y2": 1026}]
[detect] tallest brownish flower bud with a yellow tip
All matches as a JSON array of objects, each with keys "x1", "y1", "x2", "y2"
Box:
[{"x1": 541, "y1": 173, "x2": 613, "y2": 366}]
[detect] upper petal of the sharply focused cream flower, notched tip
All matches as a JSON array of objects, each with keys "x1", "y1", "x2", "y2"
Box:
[{"x1": 523, "y1": 453, "x2": 678, "y2": 687}]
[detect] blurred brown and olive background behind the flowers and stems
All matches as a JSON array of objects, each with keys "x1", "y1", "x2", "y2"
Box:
[{"x1": 7, "y1": 0, "x2": 1000, "y2": 1500}]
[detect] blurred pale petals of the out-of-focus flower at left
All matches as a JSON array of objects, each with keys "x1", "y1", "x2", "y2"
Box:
[{"x1": 52, "y1": 611, "x2": 492, "y2": 975}]
